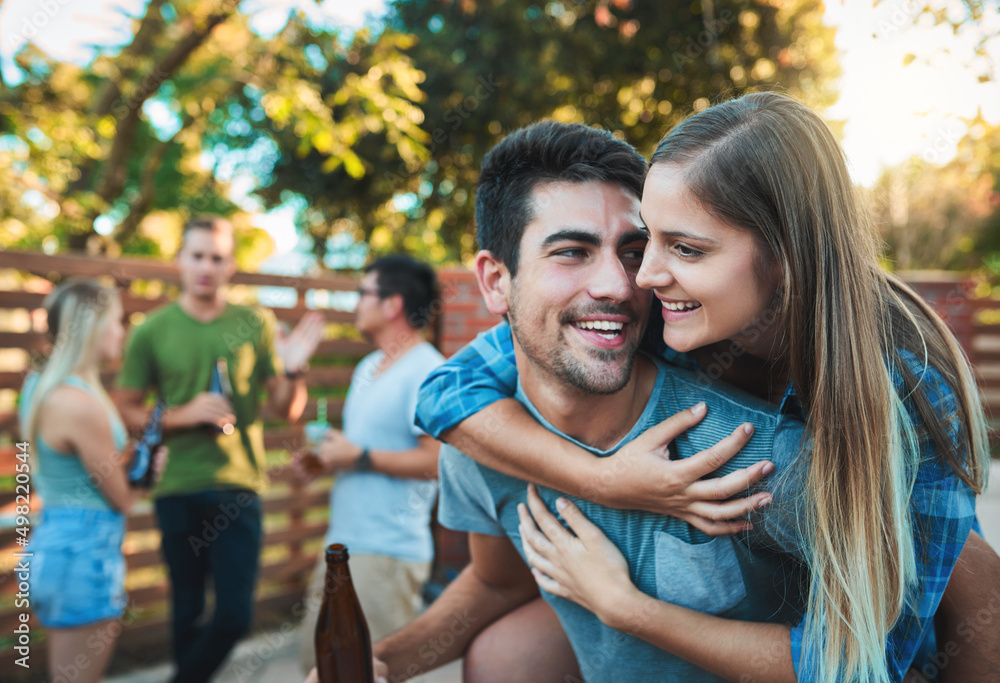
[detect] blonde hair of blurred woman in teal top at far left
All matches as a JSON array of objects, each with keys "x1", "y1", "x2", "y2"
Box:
[{"x1": 21, "y1": 279, "x2": 119, "y2": 448}]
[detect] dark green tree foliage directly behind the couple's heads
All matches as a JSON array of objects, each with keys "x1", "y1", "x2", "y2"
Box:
[{"x1": 264, "y1": 0, "x2": 838, "y2": 261}]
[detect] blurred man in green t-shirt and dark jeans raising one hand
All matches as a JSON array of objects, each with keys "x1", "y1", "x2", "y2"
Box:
[{"x1": 118, "y1": 217, "x2": 323, "y2": 683}]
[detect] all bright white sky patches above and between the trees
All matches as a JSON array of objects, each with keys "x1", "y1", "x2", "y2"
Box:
[{"x1": 0, "y1": 0, "x2": 1000, "y2": 253}]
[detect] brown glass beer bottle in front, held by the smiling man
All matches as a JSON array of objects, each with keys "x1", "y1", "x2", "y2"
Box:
[{"x1": 316, "y1": 543, "x2": 375, "y2": 683}]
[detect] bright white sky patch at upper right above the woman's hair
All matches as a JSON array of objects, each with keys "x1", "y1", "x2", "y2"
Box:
[{"x1": 825, "y1": 0, "x2": 1000, "y2": 185}]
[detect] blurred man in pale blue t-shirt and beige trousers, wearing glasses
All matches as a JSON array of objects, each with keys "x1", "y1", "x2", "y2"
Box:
[{"x1": 295, "y1": 254, "x2": 444, "y2": 671}]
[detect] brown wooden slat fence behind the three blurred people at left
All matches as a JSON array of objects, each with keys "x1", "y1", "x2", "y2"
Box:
[{"x1": 0, "y1": 252, "x2": 373, "y2": 680}]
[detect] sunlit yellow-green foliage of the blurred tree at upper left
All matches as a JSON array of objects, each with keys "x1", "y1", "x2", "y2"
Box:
[{"x1": 0, "y1": 0, "x2": 425, "y2": 264}]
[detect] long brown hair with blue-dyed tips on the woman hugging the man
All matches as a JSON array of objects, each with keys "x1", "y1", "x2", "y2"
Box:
[{"x1": 650, "y1": 92, "x2": 989, "y2": 683}]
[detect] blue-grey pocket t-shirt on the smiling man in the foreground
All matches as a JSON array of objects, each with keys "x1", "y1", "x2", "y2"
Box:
[{"x1": 438, "y1": 358, "x2": 805, "y2": 683}]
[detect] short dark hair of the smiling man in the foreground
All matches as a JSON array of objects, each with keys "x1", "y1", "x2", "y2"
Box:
[{"x1": 476, "y1": 121, "x2": 646, "y2": 276}]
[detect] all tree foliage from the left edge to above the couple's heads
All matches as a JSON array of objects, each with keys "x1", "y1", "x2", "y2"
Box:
[{"x1": 0, "y1": 0, "x2": 838, "y2": 262}]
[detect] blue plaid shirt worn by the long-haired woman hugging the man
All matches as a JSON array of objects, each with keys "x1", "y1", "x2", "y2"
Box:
[{"x1": 416, "y1": 323, "x2": 980, "y2": 681}]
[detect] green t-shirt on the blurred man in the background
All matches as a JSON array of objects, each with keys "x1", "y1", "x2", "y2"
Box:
[{"x1": 118, "y1": 303, "x2": 283, "y2": 497}]
